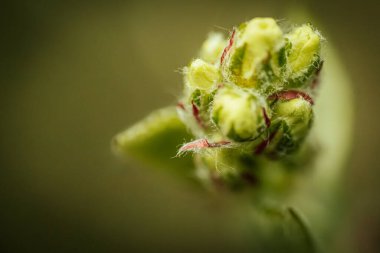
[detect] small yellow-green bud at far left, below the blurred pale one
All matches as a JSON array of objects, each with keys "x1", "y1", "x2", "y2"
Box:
[{"x1": 185, "y1": 59, "x2": 219, "y2": 90}]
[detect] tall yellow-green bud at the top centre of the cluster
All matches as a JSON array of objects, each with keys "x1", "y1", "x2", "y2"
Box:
[{"x1": 224, "y1": 18, "x2": 283, "y2": 87}]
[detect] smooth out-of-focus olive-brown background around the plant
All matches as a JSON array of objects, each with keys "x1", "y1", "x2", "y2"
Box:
[{"x1": 0, "y1": 0, "x2": 380, "y2": 252}]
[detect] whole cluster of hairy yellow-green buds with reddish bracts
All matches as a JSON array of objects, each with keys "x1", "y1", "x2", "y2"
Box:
[{"x1": 178, "y1": 18, "x2": 323, "y2": 182}]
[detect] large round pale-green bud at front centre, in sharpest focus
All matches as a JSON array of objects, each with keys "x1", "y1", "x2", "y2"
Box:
[{"x1": 211, "y1": 87, "x2": 265, "y2": 141}]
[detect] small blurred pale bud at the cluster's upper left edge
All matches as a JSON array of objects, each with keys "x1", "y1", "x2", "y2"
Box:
[{"x1": 199, "y1": 32, "x2": 227, "y2": 64}]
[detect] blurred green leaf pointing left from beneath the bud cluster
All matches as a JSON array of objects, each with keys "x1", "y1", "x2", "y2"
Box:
[{"x1": 112, "y1": 107, "x2": 194, "y2": 173}]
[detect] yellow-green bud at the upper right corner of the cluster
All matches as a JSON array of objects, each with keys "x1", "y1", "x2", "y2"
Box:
[{"x1": 287, "y1": 25, "x2": 321, "y2": 78}]
